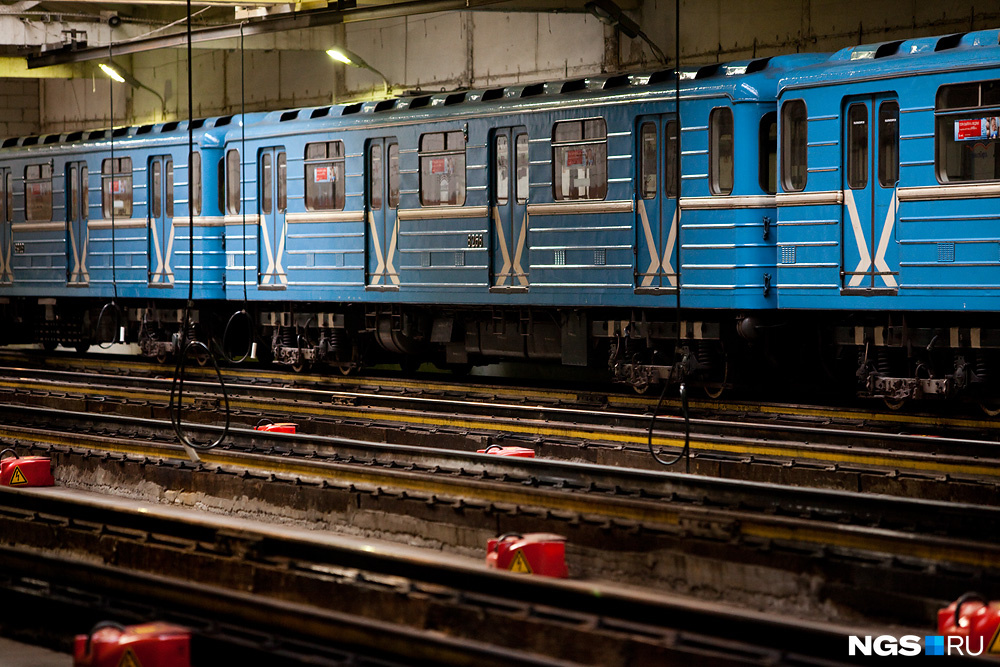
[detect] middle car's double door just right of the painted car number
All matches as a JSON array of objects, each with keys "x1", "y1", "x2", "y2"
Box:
[{"x1": 490, "y1": 127, "x2": 528, "y2": 290}]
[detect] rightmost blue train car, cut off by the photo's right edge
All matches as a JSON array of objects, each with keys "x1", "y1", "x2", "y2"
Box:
[{"x1": 775, "y1": 30, "x2": 1000, "y2": 411}]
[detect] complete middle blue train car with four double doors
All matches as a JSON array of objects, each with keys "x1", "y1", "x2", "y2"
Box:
[{"x1": 213, "y1": 55, "x2": 819, "y2": 388}]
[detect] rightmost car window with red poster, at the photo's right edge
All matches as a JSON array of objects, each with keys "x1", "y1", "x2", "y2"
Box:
[{"x1": 934, "y1": 81, "x2": 1000, "y2": 183}]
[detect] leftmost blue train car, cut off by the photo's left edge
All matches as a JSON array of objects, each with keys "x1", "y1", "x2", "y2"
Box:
[{"x1": 0, "y1": 117, "x2": 242, "y2": 356}]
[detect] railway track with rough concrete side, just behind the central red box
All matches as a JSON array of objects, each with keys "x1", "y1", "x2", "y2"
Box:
[{"x1": 0, "y1": 408, "x2": 1000, "y2": 625}]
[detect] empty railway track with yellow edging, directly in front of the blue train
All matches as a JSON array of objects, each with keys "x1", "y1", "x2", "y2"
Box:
[{"x1": 0, "y1": 354, "x2": 1000, "y2": 504}]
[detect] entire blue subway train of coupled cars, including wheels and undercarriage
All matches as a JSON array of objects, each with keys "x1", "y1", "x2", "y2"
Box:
[{"x1": 0, "y1": 30, "x2": 1000, "y2": 410}]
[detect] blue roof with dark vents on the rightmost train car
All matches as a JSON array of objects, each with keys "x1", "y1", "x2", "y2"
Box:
[{"x1": 778, "y1": 29, "x2": 1000, "y2": 95}]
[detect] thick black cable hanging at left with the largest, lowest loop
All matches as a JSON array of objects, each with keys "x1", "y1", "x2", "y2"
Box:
[{"x1": 170, "y1": 0, "x2": 232, "y2": 458}]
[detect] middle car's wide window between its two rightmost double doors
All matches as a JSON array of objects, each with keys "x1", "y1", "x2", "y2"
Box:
[{"x1": 552, "y1": 118, "x2": 608, "y2": 201}]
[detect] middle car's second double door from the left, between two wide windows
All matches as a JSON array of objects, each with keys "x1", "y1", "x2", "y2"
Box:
[{"x1": 365, "y1": 137, "x2": 399, "y2": 289}]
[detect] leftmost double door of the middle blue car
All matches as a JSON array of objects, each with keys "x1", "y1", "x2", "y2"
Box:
[{"x1": 257, "y1": 146, "x2": 288, "y2": 289}]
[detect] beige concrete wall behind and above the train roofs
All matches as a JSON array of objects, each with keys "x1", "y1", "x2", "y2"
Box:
[{"x1": 25, "y1": 0, "x2": 1000, "y2": 134}]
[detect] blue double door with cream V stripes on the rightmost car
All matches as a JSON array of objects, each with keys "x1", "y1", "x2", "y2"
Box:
[{"x1": 841, "y1": 94, "x2": 899, "y2": 294}]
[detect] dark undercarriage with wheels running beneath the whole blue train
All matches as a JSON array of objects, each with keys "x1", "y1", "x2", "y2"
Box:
[{"x1": 0, "y1": 299, "x2": 1000, "y2": 415}]
